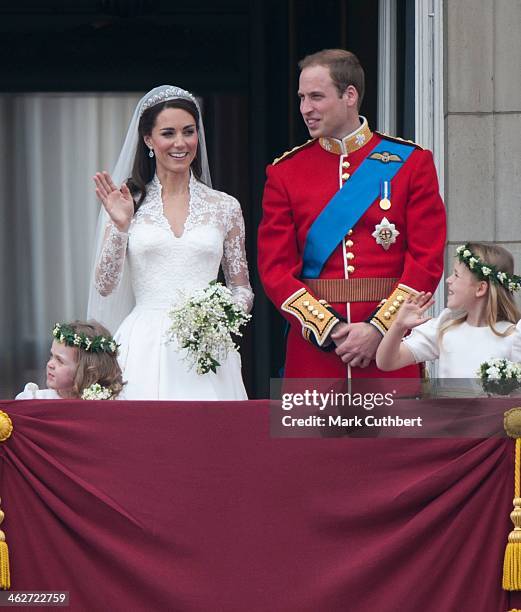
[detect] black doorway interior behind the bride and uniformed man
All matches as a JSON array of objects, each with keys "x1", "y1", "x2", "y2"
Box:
[{"x1": 0, "y1": 0, "x2": 410, "y2": 398}]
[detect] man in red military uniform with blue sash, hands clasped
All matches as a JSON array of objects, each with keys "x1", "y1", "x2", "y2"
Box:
[{"x1": 258, "y1": 49, "x2": 446, "y2": 378}]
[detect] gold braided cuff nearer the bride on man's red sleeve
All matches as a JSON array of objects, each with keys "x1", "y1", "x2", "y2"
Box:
[{"x1": 281, "y1": 288, "x2": 339, "y2": 346}]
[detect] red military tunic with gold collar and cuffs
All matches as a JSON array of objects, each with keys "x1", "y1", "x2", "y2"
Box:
[{"x1": 258, "y1": 120, "x2": 446, "y2": 378}]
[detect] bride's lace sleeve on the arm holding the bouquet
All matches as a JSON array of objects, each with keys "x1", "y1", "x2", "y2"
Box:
[{"x1": 222, "y1": 199, "x2": 253, "y2": 312}]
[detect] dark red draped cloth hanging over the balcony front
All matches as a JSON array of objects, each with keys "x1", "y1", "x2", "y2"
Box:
[{"x1": 0, "y1": 400, "x2": 513, "y2": 612}]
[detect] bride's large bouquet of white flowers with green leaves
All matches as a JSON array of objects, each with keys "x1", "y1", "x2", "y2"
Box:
[{"x1": 166, "y1": 281, "x2": 251, "y2": 374}]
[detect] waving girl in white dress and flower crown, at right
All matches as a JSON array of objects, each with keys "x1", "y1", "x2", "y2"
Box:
[{"x1": 376, "y1": 242, "x2": 521, "y2": 378}]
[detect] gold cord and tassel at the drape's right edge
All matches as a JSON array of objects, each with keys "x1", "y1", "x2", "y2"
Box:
[{"x1": 503, "y1": 438, "x2": 521, "y2": 591}]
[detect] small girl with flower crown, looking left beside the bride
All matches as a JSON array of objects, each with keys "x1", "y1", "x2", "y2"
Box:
[{"x1": 16, "y1": 321, "x2": 123, "y2": 399}]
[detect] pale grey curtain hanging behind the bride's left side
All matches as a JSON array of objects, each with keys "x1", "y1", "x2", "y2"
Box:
[{"x1": 0, "y1": 93, "x2": 141, "y2": 398}]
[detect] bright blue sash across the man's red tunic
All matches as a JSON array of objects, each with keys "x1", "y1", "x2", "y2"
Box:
[{"x1": 301, "y1": 140, "x2": 415, "y2": 278}]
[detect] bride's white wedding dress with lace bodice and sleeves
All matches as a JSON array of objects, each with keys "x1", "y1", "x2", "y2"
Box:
[{"x1": 96, "y1": 176, "x2": 253, "y2": 400}]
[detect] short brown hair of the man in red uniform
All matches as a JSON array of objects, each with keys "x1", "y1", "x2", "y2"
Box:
[{"x1": 298, "y1": 49, "x2": 365, "y2": 108}]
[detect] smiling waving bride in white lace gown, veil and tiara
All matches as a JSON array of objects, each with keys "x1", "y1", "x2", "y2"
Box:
[{"x1": 88, "y1": 85, "x2": 253, "y2": 400}]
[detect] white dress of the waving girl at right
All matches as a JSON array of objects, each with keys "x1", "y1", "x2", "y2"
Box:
[{"x1": 403, "y1": 308, "x2": 521, "y2": 378}]
